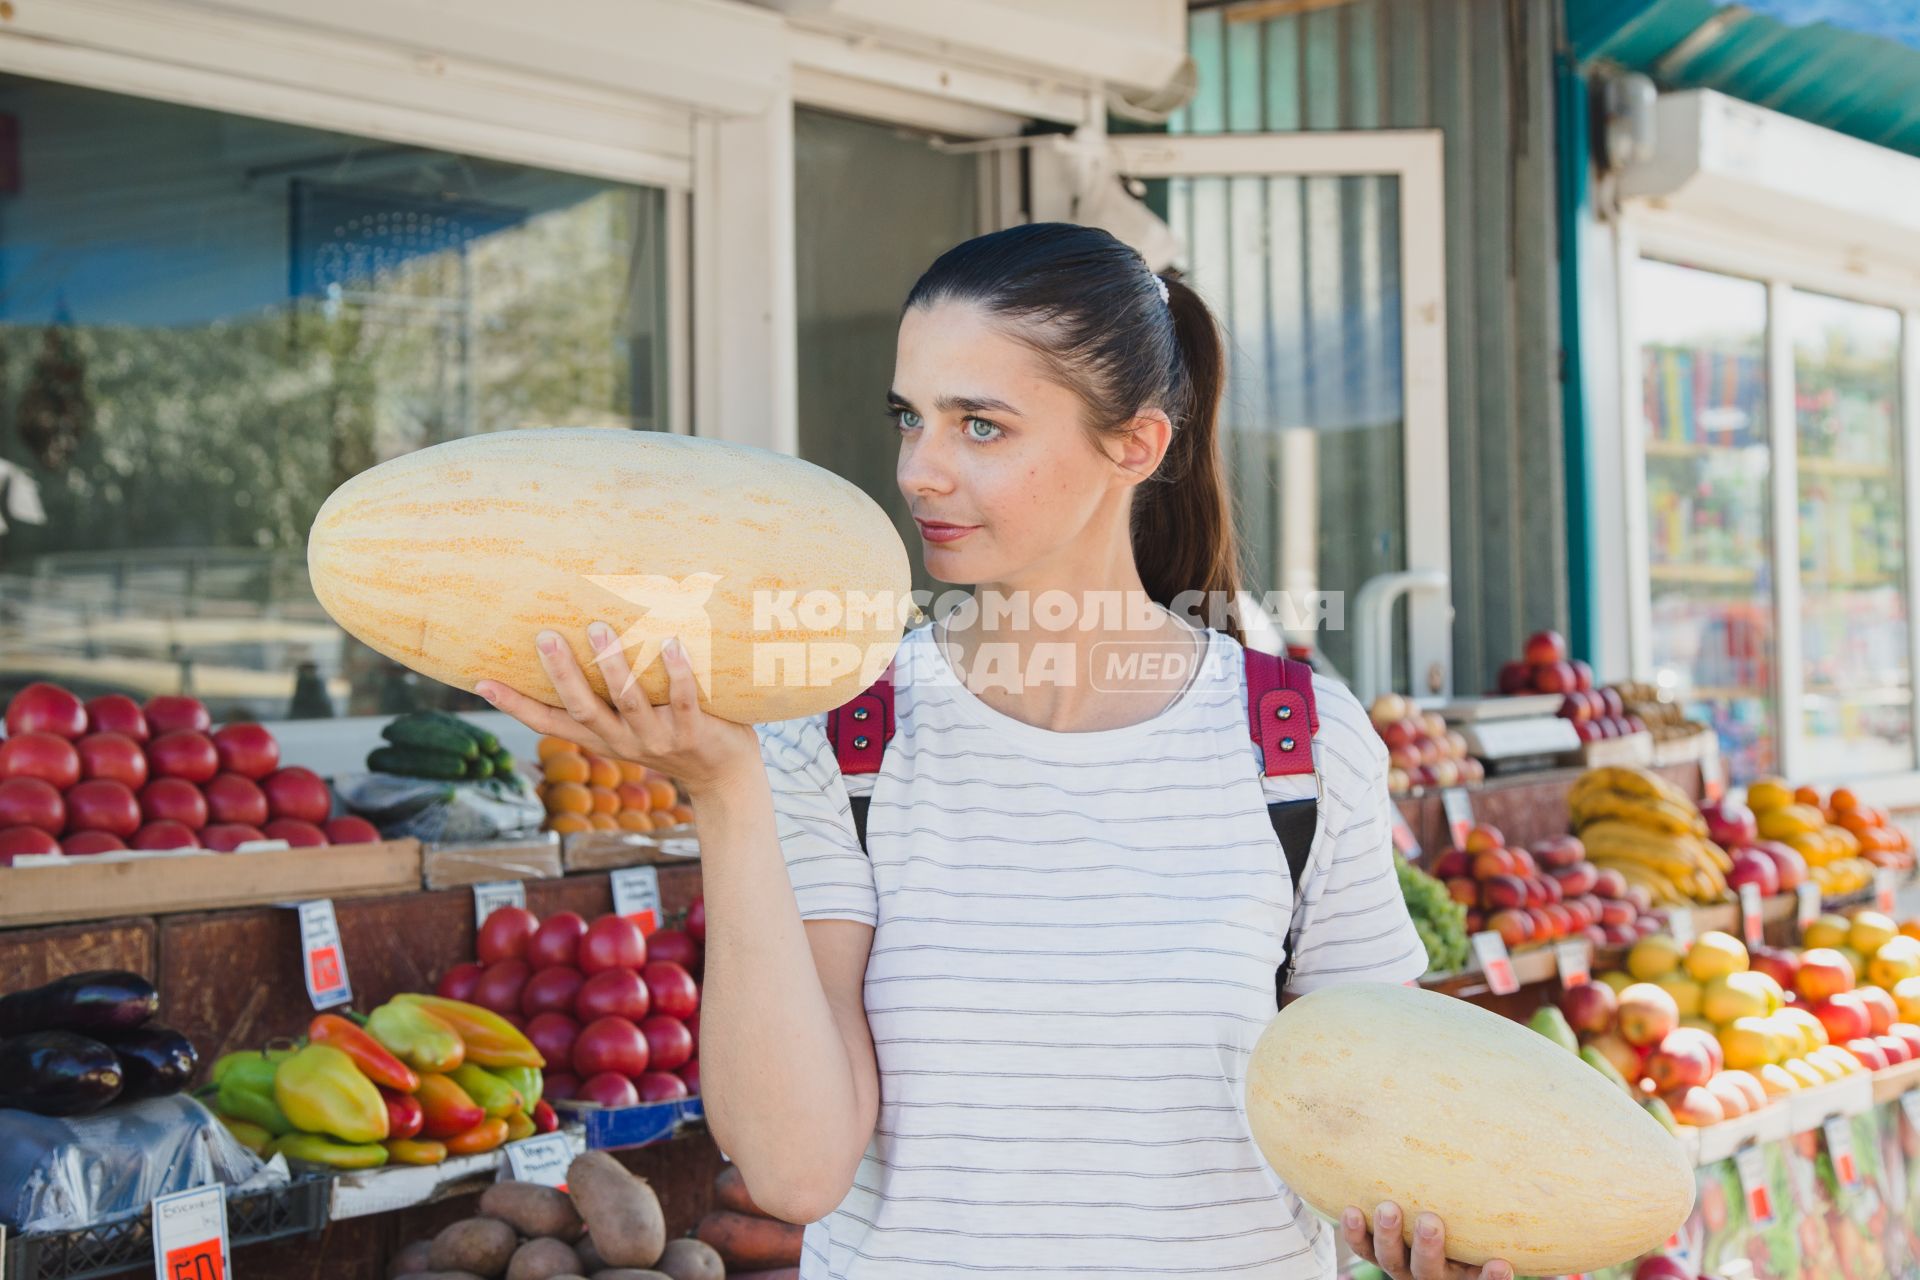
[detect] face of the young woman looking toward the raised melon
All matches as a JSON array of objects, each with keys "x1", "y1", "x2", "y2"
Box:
[{"x1": 887, "y1": 301, "x2": 1158, "y2": 583}]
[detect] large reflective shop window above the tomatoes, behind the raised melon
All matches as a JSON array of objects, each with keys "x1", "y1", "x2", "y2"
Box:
[{"x1": 0, "y1": 77, "x2": 668, "y2": 720}]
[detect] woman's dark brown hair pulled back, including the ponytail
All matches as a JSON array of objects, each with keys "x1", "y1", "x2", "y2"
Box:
[{"x1": 902, "y1": 223, "x2": 1246, "y2": 641}]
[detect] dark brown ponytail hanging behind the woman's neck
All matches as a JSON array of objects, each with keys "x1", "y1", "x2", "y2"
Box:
[{"x1": 1133, "y1": 280, "x2": 1246, "y2": 643}]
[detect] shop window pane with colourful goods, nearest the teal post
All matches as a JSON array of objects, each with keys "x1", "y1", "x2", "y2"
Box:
[{"x1": 1634, "y1": 261, "x2": 1778, "y2": 781}]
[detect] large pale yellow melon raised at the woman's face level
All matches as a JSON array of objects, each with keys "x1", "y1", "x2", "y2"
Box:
[{"x1": 307, "y1": 428, "x2": 912, "y2": 723}]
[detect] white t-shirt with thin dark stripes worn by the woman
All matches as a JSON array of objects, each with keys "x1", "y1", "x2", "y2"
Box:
[{"x1": 760, "y1": 628, "x2": 1427, "y2": 1280}]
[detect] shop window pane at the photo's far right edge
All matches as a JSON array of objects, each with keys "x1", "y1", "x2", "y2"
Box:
[{"x1": 1791, "y1": 294, "x2": 1914, "y2": 777}]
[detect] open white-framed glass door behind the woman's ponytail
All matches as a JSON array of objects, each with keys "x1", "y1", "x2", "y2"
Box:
[{"x1": 1114, "y1": 130, "x2": 1452, "y2": 695}]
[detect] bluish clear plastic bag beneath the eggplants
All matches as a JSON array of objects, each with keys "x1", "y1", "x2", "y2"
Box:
[{"x1": 0, "y1": 1094, "x2": 288, "y2": 1234}]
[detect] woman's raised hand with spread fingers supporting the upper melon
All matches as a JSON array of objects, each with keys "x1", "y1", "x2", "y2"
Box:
[{"x1": 474, "y1": 622, "x2": 762, "y2": 800}]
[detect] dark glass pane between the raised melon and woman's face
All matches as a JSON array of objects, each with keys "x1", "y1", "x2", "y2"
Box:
[{"x1": 793, "y1": 111, "x2": 985, "y2": 591}]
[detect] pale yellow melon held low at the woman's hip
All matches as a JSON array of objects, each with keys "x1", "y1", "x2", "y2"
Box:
[{"x1": 1246, "y1": 983, "x2": 1693, "y2": 1276}]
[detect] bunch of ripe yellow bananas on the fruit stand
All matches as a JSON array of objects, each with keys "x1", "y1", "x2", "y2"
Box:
[{"x1": 1567, "y1": 768, "x2": 1734, "y2": 906}]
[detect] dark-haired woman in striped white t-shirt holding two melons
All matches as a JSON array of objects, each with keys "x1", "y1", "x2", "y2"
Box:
[{"x1": 480, "y1": 225, "x2": 1511, "y2": 1280}]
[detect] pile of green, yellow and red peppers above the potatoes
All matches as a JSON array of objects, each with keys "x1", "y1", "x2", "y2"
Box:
[{"x1": 202, "y1": 992, "x2": 559, "y2": 1169}]
